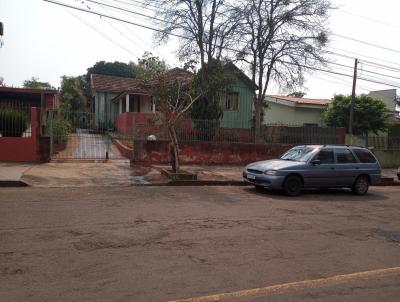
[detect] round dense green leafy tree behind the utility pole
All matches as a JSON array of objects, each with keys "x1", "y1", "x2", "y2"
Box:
[{"x1": 323, "y1": 94, "x2": 390, "y2": 136}]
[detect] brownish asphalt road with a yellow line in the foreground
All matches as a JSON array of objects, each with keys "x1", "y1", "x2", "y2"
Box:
[{"x1": 0, "y1": 187, "x2": 400, "y2": 302}]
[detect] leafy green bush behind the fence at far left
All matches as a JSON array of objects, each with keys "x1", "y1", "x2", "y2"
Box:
[{"x1": 0, "y1": 108, "x2": 29, "y2": 137}]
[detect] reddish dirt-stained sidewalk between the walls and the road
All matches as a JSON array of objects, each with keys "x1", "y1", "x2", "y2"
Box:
[{"x1": 0, "y1": 160, "x2": 400, "y2": 187}]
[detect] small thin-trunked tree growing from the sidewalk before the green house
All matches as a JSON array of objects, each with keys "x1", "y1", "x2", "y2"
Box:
[{"x1": 152, "y1": 73, "x2": 201, "y2": 173}]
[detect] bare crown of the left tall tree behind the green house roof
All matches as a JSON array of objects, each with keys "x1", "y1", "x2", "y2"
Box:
[{"x1": 147, "y1": 0, "x2": 238, "y2": 68}]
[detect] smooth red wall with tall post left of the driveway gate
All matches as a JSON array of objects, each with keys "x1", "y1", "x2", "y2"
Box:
[{"x1": 0, "y1": 108, "x2": 43, "y2": 162}]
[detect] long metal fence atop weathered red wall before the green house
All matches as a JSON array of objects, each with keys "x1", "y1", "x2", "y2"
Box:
[{"x1": 130, "y1": 116, "x2": 345, "y2": 144}]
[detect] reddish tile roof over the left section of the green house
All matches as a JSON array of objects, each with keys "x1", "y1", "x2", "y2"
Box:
[{"x1": 90, "y1": 74, "x2": 150, "y2": 94}]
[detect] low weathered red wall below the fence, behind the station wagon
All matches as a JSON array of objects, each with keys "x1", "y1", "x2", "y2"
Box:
[{"x1": 134, "y1": 140, "x2": 292, "y2": 164}]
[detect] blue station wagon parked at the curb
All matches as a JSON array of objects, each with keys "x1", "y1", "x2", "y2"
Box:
[{"x1": 243, "y1": 145, "x2": 381, "y2": 196}]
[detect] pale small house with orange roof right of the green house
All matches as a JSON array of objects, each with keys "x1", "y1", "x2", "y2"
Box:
[{"x1": 263, "y1": 95, "x2": 331, "y2": 126}]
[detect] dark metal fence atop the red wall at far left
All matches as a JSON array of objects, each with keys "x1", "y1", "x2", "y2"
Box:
[{"x1": 0, "y1": 103, "x2": 32, "y2": 137}]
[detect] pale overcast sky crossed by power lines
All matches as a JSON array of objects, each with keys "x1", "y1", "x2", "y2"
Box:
[{"x1": 0, "y1": 0, "x2": 400, "y2": 99}]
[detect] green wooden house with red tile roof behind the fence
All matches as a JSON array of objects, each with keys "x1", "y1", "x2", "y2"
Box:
[{"x1": 90, "y1": 63, "x2": 253, "y2": 129}]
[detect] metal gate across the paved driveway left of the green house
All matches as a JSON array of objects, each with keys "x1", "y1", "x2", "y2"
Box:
[{"x1": 46, "y1": 111, "x2": 132, "y2": 160}]
